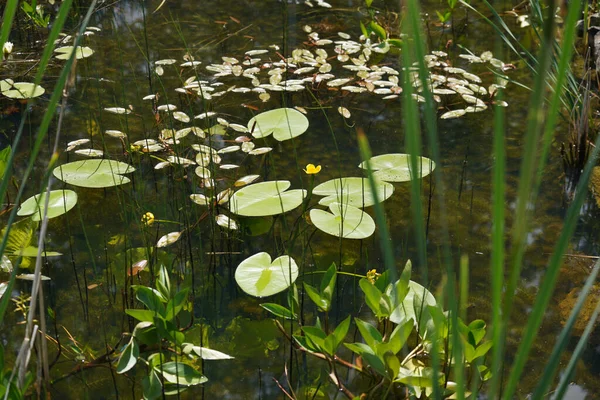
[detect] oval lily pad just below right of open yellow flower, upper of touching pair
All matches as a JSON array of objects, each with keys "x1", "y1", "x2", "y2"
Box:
[{"x1": 313, "y1": 178, "x2": 394, "y2": 208}]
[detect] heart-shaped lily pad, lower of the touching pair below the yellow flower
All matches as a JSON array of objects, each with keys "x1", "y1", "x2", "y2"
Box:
[{"x1": 310, "y1": 203, "x2": 375, "y2": 239}]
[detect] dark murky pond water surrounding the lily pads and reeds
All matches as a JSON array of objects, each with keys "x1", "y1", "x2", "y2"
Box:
[{"x1": 0, "y1": 0, "x2": 600, "y2": 399}]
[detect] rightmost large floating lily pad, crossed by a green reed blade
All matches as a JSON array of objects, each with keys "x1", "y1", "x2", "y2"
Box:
[{"x1": 358, "y1": 154, "x2": 435, "y2": 182}]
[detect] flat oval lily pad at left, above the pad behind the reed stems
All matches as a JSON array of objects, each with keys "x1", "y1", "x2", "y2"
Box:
[{"x1": 53, "y1": 160, "x2": 135, "y2": 188}]
